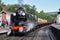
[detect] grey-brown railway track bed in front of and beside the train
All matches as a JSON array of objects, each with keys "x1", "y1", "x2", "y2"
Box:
[{"x1": 0, "y1": 26, "x2": 51, "y2": 40}]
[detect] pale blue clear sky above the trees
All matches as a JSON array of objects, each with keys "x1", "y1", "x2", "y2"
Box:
[{"x1": 2, "y1": 0, "x2": 60, "y2": 12}]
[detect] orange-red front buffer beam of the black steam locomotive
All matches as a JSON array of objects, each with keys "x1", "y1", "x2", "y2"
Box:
[{"x1": 7, "y1": 26, "x2": 27, "y2": 36}]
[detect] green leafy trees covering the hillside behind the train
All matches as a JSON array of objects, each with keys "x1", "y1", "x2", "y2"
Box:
[{"x1": 1, "y1": 3, "x2": 55, "y2": 20}]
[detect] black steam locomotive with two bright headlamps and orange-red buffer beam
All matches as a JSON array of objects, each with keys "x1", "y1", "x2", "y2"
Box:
[{"x1": 7, "y1": 7, "x2": 37, "y2": 36}]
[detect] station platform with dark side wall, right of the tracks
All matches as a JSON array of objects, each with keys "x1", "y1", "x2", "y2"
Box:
[{"x1": 50, "y1": 24, "x2": 60, "y2": 40}]
